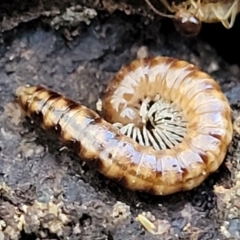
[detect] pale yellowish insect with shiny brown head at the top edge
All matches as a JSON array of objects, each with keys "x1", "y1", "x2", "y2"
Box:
[{"x1": 145, "y1": 0, "x2": 240, "y2": 36}]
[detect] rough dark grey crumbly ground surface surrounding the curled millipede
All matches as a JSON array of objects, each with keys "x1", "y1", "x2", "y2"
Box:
[{"x1": 0, "y1": 10, "x2": 240, "y2": 240}]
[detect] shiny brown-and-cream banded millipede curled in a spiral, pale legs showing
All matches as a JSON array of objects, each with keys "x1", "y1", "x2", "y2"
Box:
[{"x1": 16, "y1": 57, "x2": 233, "y2": 195}]
